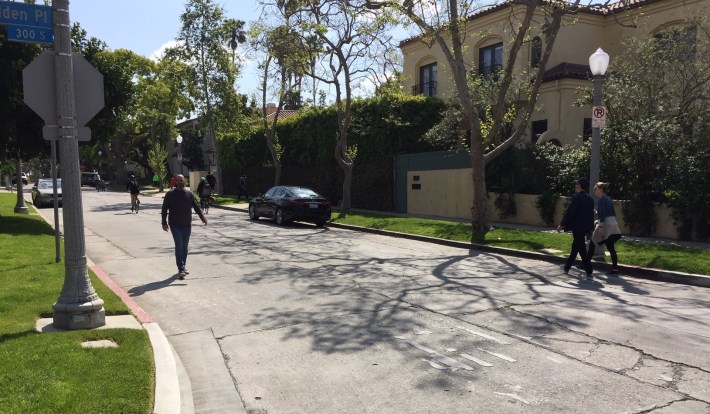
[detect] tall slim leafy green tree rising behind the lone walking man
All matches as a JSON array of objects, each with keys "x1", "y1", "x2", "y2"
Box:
[{"x1": 166, "y1": 0, "x2": 249, "y2": 191}]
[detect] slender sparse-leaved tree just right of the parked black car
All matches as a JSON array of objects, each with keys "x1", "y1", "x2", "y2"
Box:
[{"x1": 276, "y1": 0, "x2": 400, "y2": 213}]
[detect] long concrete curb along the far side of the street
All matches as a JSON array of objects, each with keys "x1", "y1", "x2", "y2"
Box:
[{"x1": 213, "y1": 206, "x2": 710, "y2": 287}]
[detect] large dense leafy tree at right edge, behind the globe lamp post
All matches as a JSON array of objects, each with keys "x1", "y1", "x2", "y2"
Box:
[{"x1": 601, "y1": 20, "x2": 710, "y2": 239}]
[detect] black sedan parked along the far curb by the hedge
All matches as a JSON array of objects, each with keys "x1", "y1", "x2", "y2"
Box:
[{"x1": 249, "y1": 186, "x2": 330, "y2": 227}]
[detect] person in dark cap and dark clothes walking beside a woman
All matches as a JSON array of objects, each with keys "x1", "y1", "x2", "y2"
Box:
[{"x1": 557, "y1": 177, "x2": 594, "y2": 280}]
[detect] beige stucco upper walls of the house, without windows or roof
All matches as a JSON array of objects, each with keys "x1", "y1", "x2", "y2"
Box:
[{"x1": 402, "y1": 0, "x2": 710, "y2": 145}]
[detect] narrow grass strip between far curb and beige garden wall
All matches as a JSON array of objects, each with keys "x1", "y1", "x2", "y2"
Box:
[{"x1": 331, "y1": 212, "x2": 710, "y2": 275}]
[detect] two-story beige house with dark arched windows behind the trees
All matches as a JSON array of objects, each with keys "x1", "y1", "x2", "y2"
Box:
[{"x1": 400, "y1": 0, "x2": 710, "y2": 145}]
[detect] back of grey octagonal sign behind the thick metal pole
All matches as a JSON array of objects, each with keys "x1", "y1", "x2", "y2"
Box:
[{"x1": 22, "y1": 50, "x2": 104, "y2": 132}]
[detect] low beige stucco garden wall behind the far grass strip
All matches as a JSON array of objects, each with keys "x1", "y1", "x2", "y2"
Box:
[{"x1": 407, "y1": 168, "x2": 678, "y2": 239}]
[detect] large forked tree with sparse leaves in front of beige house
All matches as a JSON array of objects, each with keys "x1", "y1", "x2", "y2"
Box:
[{"x1": 376, "y1": 0, "x2": 580, "y2": 240}]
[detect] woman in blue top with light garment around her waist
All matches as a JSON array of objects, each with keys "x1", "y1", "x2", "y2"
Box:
[{"x1": 588, "y1": 182, "x2": 621, "y2": 275}]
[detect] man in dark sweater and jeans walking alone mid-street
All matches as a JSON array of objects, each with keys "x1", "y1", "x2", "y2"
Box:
[{"x1": 160, "y1": 174, "x2": 207, "y2": 280}]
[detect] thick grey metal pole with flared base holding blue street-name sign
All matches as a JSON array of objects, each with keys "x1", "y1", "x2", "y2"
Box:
[{"x1": 52, "y1": 0, "x2": 106, "y2": 330}]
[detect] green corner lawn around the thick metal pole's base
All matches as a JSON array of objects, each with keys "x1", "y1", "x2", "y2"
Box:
[{"x1": 0, "y1": 194, "x2": 155, "y2": 413}]
